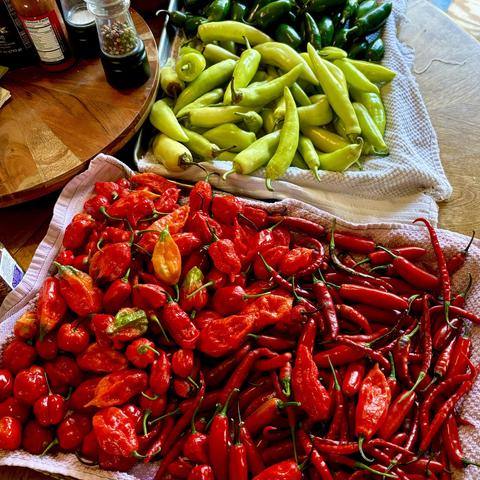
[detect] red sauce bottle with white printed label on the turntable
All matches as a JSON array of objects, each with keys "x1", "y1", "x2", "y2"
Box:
[{"x1": 11, "y1": 0, "x2": 75, "y2": 71}]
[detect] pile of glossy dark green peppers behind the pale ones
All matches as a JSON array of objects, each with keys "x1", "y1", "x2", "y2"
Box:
[{"x1": 168, "y1": 0, "x2": 392, "y2": 61}]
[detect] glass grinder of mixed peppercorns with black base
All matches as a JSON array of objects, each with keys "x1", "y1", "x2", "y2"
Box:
[{"x1": 85, "y1": 0, "x2": 150, "y2": 88}]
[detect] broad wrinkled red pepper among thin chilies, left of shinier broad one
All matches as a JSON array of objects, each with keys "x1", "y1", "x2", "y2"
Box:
[{"x1": 292, "y1": 345, "x2": 331, "y2": 421}]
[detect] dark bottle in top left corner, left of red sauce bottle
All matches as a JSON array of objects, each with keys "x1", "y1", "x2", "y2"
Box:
[{"x1": 0, "y1": 0, "x2": 37, "y2": 68}]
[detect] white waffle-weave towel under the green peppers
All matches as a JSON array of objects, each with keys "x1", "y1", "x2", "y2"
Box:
[{"x1": 136, "y1": 0, "x2": 452, "y2": 224}]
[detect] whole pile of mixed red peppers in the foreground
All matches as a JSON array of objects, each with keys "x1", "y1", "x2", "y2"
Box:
[{"x1": 0, "y1": 173, "x2": 480, "y2": 480}]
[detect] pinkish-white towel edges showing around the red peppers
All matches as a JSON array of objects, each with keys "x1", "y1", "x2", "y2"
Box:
[{"x1": 0, "y1": 155, "x2": 480, "y2": 480}]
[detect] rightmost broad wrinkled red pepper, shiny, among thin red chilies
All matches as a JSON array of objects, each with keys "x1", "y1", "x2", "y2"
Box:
[{"x1": 355, "y1": 363, "x2": 391, "y2": 451}]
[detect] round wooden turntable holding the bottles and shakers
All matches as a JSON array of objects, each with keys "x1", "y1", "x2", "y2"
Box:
[{"x1": 0, "y1": 12, "x2": 159, "y2": 207}]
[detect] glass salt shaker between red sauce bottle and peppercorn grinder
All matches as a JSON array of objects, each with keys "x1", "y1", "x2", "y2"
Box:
[{"x1": 60, "y1": 0, "x2": 100, "y2": 58}]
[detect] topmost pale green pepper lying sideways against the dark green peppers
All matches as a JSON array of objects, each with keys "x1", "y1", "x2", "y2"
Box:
[{"x1": 198, "y1": 20, "x2": 272, "y2": 45}]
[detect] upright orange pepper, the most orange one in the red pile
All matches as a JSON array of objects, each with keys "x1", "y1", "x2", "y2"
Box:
[{"x1": 152, "y1": 227, "x2": 182, "y2": 285}]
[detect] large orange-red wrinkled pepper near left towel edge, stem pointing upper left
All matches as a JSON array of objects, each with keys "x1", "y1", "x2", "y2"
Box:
[{"x1": 57, "y1": 264, "x2": 102, "y2": 317}]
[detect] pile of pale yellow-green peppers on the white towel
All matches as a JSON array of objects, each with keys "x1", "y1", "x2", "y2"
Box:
[{"x1": 150, "y1": 29, "x2": 395, "y2": 190}]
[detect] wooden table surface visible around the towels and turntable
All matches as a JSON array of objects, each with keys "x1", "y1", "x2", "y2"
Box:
[{"x1": 0, "y1": 0, "x2": 480, "y2": 480}]
